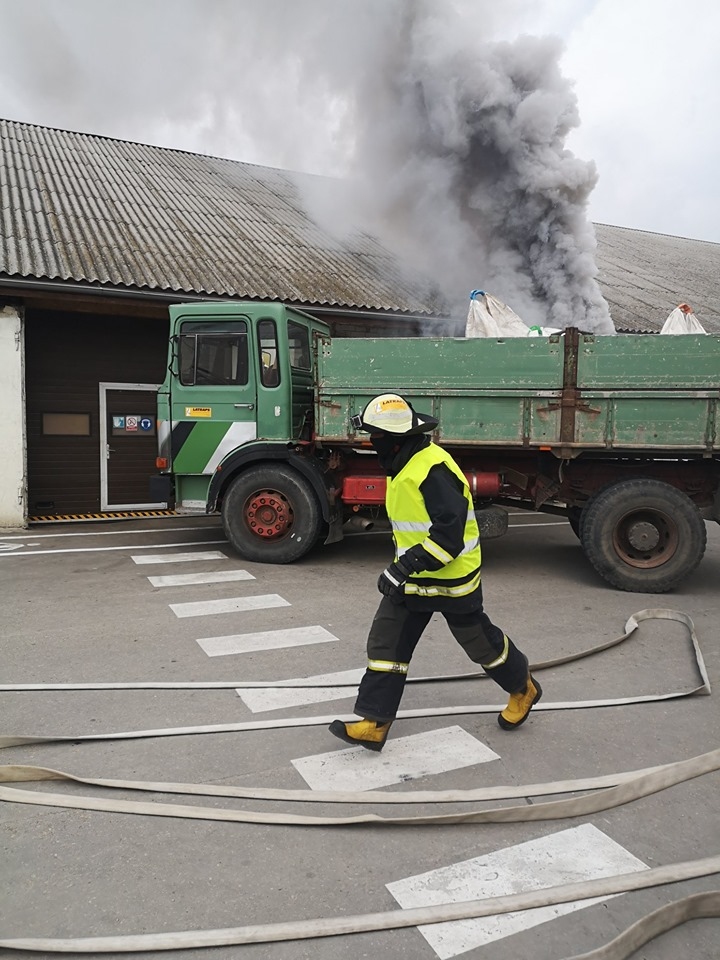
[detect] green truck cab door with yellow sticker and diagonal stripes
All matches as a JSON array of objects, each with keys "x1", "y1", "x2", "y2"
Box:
[{"x1": 170, "y1": 317, "x2": 257, "y2": 496}]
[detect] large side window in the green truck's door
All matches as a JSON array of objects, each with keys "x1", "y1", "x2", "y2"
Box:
[{"x1": 179, "y1": 320, "x2": 248, "y2": 386}]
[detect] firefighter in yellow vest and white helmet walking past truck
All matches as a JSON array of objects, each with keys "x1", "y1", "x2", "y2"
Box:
[{"x1": 329, "y1": 393, "x2": 542, "y2": 751}]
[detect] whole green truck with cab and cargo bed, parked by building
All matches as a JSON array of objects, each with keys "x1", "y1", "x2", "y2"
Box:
[{"x1": 151, "y1": 302, "x2": 720, "y2": 593}]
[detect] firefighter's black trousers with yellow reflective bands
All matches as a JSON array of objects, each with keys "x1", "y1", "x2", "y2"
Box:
[{"x1": 355, "y1": 597, "x2": 528, "y2": 723}]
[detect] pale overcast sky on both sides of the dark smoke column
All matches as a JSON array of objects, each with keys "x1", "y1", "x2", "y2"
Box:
[{"x1": 0, "y1": 0, "x2": 720, "y2": 241}]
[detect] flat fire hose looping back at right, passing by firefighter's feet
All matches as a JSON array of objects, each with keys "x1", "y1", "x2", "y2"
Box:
[{"x1": 0, "y1": 608, "x2": 710, "y2": 747}]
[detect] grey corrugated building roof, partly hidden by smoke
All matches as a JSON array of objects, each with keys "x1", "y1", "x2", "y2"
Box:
[{"x1": 0, "y1": 120, "x2": 720, "y2": 333}]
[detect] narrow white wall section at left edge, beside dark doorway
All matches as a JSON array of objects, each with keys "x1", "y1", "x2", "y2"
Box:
[{"x1": 0, "y1": 307, "x2": 25, "y2": 527}]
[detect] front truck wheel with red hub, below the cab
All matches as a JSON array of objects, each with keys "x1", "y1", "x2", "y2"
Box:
[{"x1": 222, "y1": 465, "x2": 322, "y2": 563}]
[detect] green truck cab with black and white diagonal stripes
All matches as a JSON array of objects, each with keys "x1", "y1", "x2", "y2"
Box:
[{"x1": 153, "y1": 302, "x2": 330, "y2": 560}]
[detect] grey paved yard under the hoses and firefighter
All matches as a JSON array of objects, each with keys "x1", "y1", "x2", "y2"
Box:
[{"x1": 0, "y1": 515, "x2": 720, "y2": 960}]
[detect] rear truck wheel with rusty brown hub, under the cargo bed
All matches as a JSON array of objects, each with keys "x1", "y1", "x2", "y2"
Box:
[{"x1": 580, "y1": 479, "x2": 707, "y2": 593}]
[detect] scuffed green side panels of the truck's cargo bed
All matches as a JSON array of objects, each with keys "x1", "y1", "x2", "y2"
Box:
[{"x1": 316, "y1": 335, "x2": 720, "y2": 455}]
